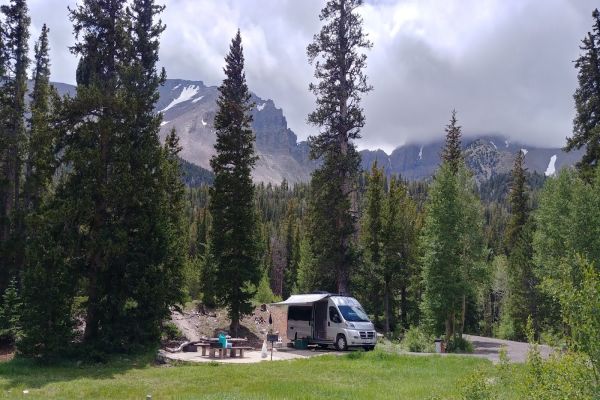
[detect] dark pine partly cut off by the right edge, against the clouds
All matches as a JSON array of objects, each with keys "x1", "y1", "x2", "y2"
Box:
[{"x1": 565, "y1": 9, "x2": 600, "y2": 179}]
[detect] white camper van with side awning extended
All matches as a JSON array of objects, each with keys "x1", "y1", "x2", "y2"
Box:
[{"x1": 273, "y1": 293, "x2": 377, "y2": 350}]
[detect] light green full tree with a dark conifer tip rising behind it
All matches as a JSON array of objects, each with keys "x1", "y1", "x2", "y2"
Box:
[{"x1": 421, "y1": 163, "x2": 483, "y2": 341}]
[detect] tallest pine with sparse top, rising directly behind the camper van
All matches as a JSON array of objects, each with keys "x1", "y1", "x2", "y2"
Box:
[{"x1": 307, "y1": 0, "x2": 372, "y2": 293}]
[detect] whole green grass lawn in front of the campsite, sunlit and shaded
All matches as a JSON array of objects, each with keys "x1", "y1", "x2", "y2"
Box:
[{"x1": 0, "y1": 351, "x2": 491, "y2": 400}]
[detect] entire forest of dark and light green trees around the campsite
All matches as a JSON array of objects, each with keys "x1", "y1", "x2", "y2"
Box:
[{"x1": 0, "y1": 0, "x2": 600, "y2": 393}]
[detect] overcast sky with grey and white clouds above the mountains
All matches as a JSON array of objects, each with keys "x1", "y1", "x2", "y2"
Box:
[{"x1": 27, "y1": 0, "x2": 597, "y2": 151}]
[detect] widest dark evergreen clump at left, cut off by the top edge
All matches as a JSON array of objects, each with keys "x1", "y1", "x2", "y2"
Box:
[{"x1": 57, "y1": 0, "x2": 185, "y2": 351}]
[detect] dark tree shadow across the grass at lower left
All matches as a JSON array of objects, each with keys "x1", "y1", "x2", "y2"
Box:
[{"x1": 0, "y1": 351, "x2": 156, "y2": 393}]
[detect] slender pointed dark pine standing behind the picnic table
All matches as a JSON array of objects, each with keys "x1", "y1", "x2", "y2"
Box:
[{"x1": 210, "y1": 30, "x2": 260, "y2": 334}]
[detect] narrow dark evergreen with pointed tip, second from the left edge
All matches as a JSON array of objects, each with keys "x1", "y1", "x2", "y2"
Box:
[{"x1": 17, "y1": 25, "x2": 76, "y2": 357}]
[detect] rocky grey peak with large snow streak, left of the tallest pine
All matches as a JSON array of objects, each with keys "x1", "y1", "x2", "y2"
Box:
[{"x1": 156, "y1": 79, "x2": 313, "y2": 183}]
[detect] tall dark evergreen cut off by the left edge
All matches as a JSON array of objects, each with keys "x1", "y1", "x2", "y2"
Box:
[{"x1": 0, "y1": 0, "x2": 31, "y2": 290}]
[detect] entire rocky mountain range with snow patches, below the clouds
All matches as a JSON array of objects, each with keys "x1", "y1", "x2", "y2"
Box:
[{"x1": 48, "y1": 79, "x2": 583, "y2": 183}]
